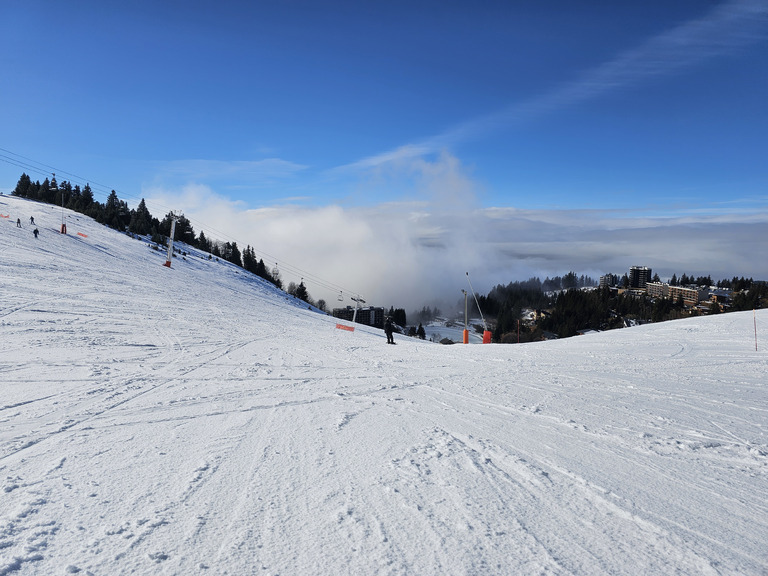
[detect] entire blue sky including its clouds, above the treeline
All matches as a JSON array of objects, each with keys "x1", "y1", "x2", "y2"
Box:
[{"x1": 0, "y1": 0, "x2": 768, "y2": 305}]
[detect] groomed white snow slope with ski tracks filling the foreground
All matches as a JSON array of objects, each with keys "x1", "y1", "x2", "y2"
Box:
[{"x1": 0, "y1": 196, "x2": 768, "y2": 576}]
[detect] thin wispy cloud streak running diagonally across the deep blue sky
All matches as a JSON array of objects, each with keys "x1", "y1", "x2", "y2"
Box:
[{"x1": 340, "y1": 0, "x2": 768, "y2": 170}]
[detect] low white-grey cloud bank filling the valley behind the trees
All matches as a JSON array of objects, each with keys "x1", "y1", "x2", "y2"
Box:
[{"x1": 145, "y1": 153, "x2": 768, "y2": 312}]
